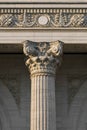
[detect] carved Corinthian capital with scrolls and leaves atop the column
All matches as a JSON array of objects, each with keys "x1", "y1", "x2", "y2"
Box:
[{"x1": 23, "y1": 41, "x2": 63, "y2": 75}]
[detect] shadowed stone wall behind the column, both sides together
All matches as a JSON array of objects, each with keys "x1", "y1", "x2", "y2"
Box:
[{"x1": 0, "y1": 54, "x2": 87, "y2": 130}]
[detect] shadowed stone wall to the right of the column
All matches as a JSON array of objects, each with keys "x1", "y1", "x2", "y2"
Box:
[{"x1": 56, "y1": 54, "x2": 87, "y2": 130}]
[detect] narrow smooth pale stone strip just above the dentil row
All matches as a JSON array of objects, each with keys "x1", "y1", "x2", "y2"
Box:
[{"x1": 0, "y1": 2, "x2": 87, "y2": 8}]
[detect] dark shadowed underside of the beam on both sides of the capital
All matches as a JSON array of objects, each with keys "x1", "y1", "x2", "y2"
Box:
[{"x1": 0, "y1": 43, "x2": 87, "y2": 54}]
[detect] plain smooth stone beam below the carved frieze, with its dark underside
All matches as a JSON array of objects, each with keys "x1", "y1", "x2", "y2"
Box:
[{"x1": 0, "y1": 26, "x2": 87, "y2": 53}]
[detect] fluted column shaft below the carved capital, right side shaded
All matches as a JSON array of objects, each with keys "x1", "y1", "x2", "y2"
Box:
[{"x1": 30, "y1": 75, "x2": 56, "y2": 130}]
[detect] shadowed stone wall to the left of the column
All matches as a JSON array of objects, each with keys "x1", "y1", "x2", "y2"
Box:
[{"x1": 0, "y1": 54, "x2": 30, "y2": 130}]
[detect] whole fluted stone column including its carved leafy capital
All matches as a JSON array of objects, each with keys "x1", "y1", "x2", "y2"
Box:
[{"x1": 23, "y1": 41, "x2": 63, "y2": 130}]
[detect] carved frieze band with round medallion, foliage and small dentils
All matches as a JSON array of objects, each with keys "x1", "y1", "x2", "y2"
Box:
[{"x1": 0, "y1": 9, "x2": 87, "y2": 29}]
